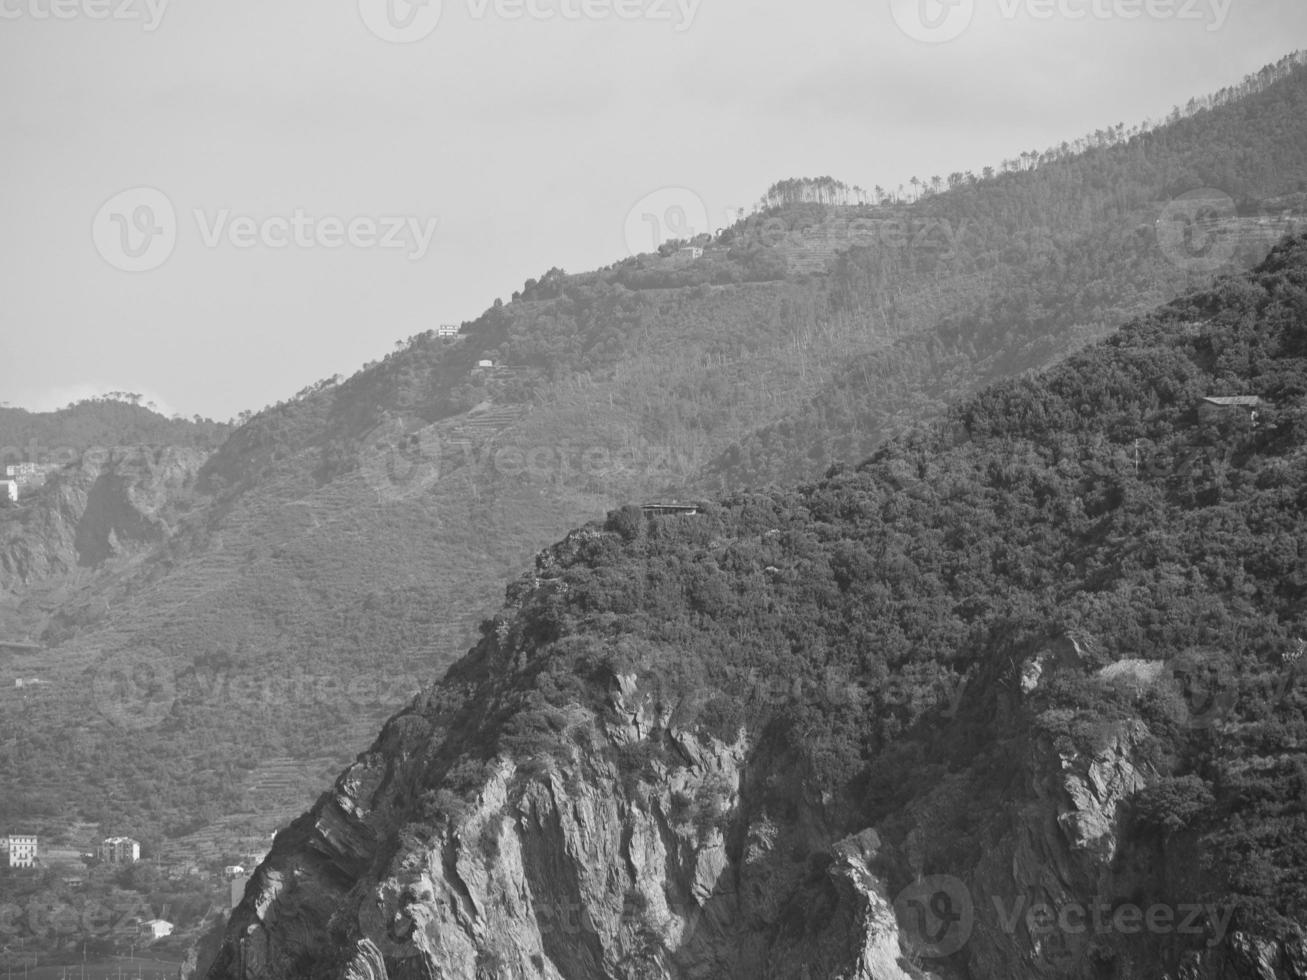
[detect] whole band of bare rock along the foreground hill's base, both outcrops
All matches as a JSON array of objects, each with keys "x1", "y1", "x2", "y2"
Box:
[{"x1": 209, "y1": 603, "x2": 1307, "y2": 980}]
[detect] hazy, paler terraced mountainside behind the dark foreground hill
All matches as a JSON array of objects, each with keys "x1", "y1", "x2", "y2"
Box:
[{"x1": 0, "y1": 48, "x2": 1307, "y2": 904}]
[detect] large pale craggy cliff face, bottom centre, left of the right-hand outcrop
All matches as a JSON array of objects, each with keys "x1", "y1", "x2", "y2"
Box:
[{"x1": 209, "y1": 606, "x2": 911, "y2": 980}]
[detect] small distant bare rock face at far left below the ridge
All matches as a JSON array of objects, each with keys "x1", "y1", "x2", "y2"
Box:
[{"x1": 0, "y1": 448, "x2": 205, "y2": 589}]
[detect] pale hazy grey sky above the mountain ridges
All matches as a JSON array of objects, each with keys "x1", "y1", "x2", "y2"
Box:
[{"x1": 0, "y1": 0, "x2": 1307, "y2": 418}]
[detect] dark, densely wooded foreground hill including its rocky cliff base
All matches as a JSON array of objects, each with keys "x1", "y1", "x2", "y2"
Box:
[{"x1": 210, "y1": 235, "x2": 1307, "y2": 980}]
